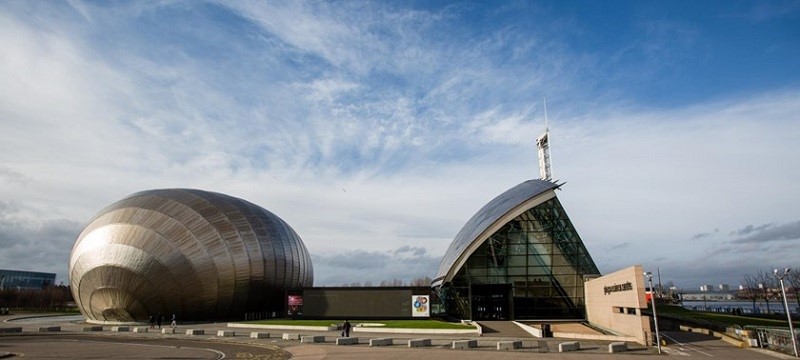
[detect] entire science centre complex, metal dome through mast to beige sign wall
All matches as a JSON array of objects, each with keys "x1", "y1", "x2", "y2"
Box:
[{"x1": 69, "y1": 128, "x2": 650, "y2": 342}]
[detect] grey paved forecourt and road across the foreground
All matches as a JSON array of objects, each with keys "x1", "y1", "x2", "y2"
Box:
[{"x1": 0, "y1": 316, "x2": 792, "y2": 360}]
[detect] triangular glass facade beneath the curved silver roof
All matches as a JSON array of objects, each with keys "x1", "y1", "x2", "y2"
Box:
[{"x1": 438, "y1": 197, "x2": 599, "y2": 320}]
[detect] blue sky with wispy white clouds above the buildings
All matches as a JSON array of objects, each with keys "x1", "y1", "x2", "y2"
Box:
[{"x1": 0, "y1": 0, "x2": 800, "y2": 290}]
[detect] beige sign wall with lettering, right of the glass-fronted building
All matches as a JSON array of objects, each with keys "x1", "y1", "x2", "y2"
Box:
[{"x1": 584, "y1": 265, "x2": 650, "y2": 344}]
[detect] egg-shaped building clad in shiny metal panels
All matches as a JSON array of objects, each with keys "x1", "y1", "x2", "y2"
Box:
[{"x1": 69, "y1": 189, "x2": 314, "y2": 321}]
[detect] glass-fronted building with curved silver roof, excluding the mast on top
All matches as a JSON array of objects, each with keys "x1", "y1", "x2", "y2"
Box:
[{"x1": 433, "y1": 179, "x2": 600, "y2": 320}]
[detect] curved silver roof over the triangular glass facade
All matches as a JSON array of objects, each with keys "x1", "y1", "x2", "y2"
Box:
[{"x1": 433, "y1": 179, "x2": 561, "y2": 286}]
